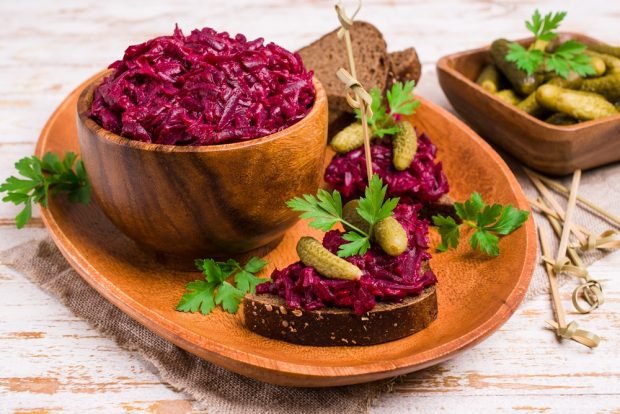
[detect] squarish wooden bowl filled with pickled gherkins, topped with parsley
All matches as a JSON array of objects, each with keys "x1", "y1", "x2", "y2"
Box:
[{"x1": 437, "y1": 13, "x2": 620, "y2": 175}]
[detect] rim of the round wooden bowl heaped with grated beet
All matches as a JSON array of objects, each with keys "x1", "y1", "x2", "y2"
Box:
[{"x1": 76, "y1": 69, "x2": 327, "y2": 153}]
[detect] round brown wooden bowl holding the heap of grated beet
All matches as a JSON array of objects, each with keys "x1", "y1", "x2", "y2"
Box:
[{"x1": 77, "y1": 72, "x2": 327, "y2": 259}]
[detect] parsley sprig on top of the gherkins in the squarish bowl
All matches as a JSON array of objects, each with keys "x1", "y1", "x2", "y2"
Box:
[{"x1": 506, "y1": 10, "x2": 595, "y2": 78}]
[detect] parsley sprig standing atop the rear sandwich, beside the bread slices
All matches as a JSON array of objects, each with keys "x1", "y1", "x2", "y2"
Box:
[{"x1": 355, "y1": 81, "x2": 420, "y2": 138}]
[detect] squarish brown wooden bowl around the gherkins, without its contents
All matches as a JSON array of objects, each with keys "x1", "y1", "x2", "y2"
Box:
[{"x1": 437, "y1": 33, "x2": 620, "y2": 175}]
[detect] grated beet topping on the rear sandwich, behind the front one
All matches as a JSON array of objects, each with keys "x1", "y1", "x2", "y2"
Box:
[{"x1": 325, "y1": 129, "x2": 449, "y2": 202}]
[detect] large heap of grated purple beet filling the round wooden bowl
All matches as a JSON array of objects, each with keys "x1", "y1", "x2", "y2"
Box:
[{"x1": 90, "y1": 27, "x2": 315, "y2": 145}]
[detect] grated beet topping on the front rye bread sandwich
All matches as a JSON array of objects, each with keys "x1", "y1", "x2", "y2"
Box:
[{"x1": 256, "y1": 204, "x2": 437, "y2": 315}]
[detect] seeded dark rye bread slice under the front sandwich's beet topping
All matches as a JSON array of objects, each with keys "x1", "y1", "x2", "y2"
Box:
[{"x1": 243, "y1": 262, "x2": 437, "y2": 346}]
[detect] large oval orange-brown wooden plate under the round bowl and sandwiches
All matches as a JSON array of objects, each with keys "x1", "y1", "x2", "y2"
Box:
[{"x1": 36, "y1": 74, "x2": 536, "y2": 387}]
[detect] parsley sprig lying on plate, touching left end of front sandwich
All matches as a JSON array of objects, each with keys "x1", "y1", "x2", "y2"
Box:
[{"x1": 176, "y1": 257, "x2": 267, "y2": 315}]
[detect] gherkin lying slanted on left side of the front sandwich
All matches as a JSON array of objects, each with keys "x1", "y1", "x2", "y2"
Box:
[{"x1": 297, "y1": 236, "x2": 362, "y2": 280}]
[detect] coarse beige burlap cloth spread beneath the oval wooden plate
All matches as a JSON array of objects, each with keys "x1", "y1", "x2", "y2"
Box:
[{"x1": 0, "y1": 163, "x2": 620, "y2": 413}]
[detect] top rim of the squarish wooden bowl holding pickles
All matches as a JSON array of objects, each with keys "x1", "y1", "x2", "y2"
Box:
[{"x1": 437, "y1": 32, "x2": 620, "y2": 133}]
